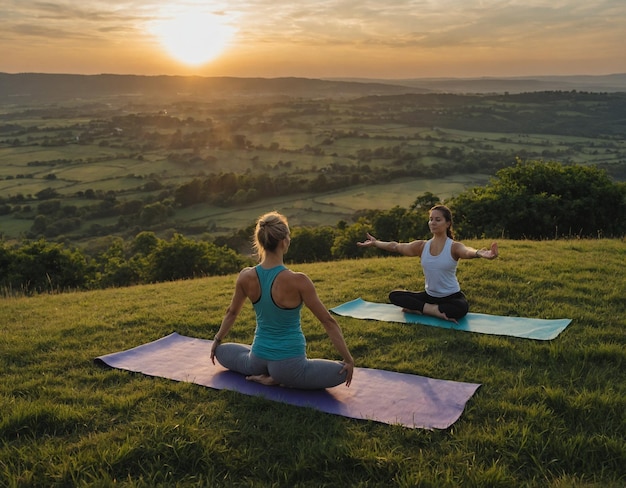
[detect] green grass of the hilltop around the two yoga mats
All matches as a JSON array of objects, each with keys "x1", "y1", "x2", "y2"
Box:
[{"x1": 0, "y1": 240, "x2": 626, "y2": 488}]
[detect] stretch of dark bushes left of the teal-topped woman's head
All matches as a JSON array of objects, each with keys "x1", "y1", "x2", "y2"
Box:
[{"x1": 0, "y1": 231, "x2": 250, "y2": 295}]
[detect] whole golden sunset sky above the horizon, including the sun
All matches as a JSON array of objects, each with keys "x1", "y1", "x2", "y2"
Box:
[{"x1": 0, "y1": 0, "x2": 626, "y2": 79}]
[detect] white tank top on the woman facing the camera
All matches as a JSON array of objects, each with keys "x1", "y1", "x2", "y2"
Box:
[{"x1": 421, "y1": 237, "x2": 461, "y2": 298}]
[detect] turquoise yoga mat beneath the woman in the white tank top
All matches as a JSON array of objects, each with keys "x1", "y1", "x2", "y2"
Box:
[{"x1": 330, "y1": 298, "x2": 571, "y2": 341}]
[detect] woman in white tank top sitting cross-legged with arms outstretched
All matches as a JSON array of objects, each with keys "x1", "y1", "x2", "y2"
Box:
[{"x1": 357, "y1": 205, "x2": 498, "y2": 322}]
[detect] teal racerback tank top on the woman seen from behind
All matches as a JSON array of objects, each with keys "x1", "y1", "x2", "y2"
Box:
[{"x1": 252, "y1": 264, "x2": 306, "y2": 360}]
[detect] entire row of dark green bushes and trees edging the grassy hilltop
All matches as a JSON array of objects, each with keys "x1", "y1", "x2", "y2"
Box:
[{"x1": 0, "y1": 159, "x2": 626, "y2": 295}]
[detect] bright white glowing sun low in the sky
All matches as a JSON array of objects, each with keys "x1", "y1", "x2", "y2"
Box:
[{"x1": 152, "y1": 8, "x2": 235, "y2": 66}]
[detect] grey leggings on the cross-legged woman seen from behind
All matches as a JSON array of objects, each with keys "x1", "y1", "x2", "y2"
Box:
[{"x1": 215, "y1": 342, "x2": 346, "y2": 390}]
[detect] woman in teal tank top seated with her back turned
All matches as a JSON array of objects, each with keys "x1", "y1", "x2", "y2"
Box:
[{"x1": 211, "y1": 212, "x2": 354, "y2": 389}]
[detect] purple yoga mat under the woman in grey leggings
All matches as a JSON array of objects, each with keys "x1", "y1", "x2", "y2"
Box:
[{"x1": 96, "y1": 333, "x2": 480, "y2": 429}]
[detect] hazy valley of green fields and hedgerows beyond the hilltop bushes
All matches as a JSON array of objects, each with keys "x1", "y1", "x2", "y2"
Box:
[{"x1": 0, "y1": 93, "x2": 626, "y2": 240}]
